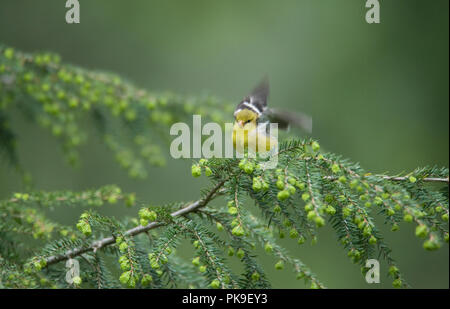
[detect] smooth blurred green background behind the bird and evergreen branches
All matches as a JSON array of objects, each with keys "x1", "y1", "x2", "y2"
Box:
[{"x1": 0, "y1": 0, "x2": 449, "y2": 288}]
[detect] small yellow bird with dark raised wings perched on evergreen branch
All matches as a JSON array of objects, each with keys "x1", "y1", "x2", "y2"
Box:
[{"x1": 233, "y1": 78, "x2": 312, "y2": 153}]
